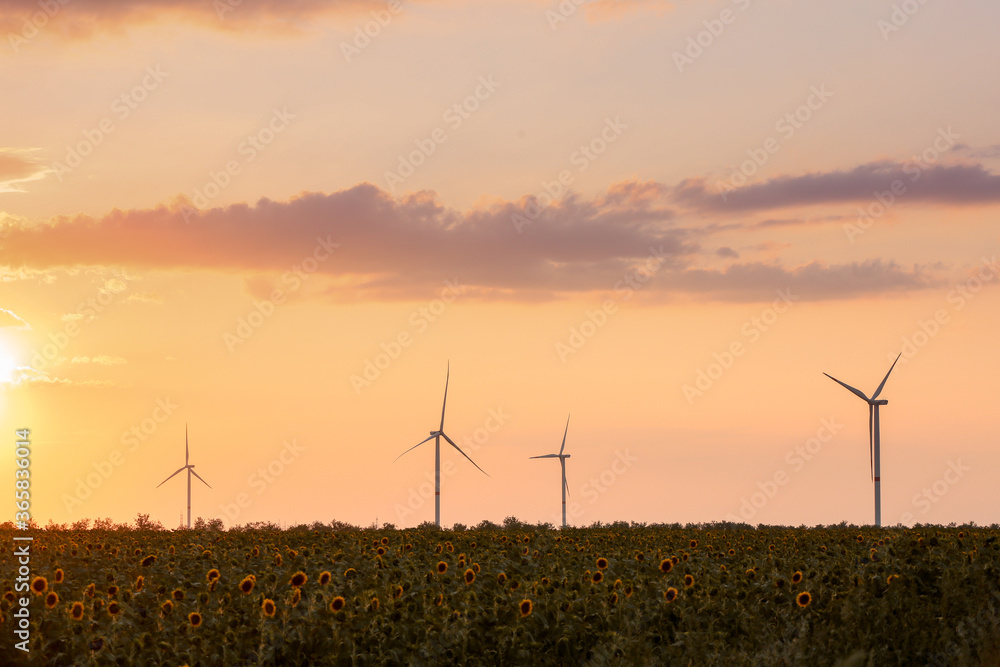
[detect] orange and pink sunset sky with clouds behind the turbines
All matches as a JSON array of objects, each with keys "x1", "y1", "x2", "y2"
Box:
[{"x1": 0, "y1": 0, "x2": 1000, "y2": 528}]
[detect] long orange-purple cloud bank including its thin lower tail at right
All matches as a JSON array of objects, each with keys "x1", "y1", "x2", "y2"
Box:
[{"x1": 0, "y1": 181, "x2": 956, "y2": 301}]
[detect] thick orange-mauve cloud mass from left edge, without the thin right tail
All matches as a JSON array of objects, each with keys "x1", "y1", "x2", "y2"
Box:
[{"x1": 0, "y1": 182, "x2": 698, "y2": 298}]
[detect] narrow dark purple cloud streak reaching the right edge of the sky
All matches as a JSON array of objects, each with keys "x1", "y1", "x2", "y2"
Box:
[{"x1": 674, "y1": 161, "x2": 1000, "y2": 211}]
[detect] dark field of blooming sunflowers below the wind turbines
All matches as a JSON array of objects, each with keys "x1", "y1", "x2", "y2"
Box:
[{"x1": 0, "y1": 524, "x2": 1000, "y2": 665}]
